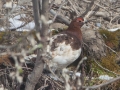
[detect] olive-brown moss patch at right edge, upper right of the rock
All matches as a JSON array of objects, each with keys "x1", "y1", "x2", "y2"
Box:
[{"x1": 99, "y1": 29, "x2": 119, "y2": 48}]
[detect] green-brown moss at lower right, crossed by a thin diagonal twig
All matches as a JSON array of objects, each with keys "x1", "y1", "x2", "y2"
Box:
[{"x1": 85, "y1": 54, "x2": 120, "y2": 77}]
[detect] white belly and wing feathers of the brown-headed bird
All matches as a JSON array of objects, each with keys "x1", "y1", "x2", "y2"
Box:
[{"x1": 47, "y1": 34, "x2": 81, "y2": 69}]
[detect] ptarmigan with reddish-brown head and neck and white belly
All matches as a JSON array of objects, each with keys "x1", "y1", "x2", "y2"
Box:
[{"x1": 47, "y1": 17, "x2": 85, "y2": 71}]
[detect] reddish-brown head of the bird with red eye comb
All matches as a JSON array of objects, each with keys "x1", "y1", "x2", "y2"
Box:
[{"x1": 70, "y1": 17, "x2": 85, "y2": 28}]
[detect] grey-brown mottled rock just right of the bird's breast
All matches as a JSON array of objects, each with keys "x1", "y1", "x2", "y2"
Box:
[{"x1": 82, "y1": 28, "x2": 106, "y2": 59}]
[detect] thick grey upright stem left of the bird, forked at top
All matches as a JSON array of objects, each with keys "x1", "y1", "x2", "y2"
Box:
[{"x1": 25, "y1": 0, "x2": 49, "y2": 90}]
